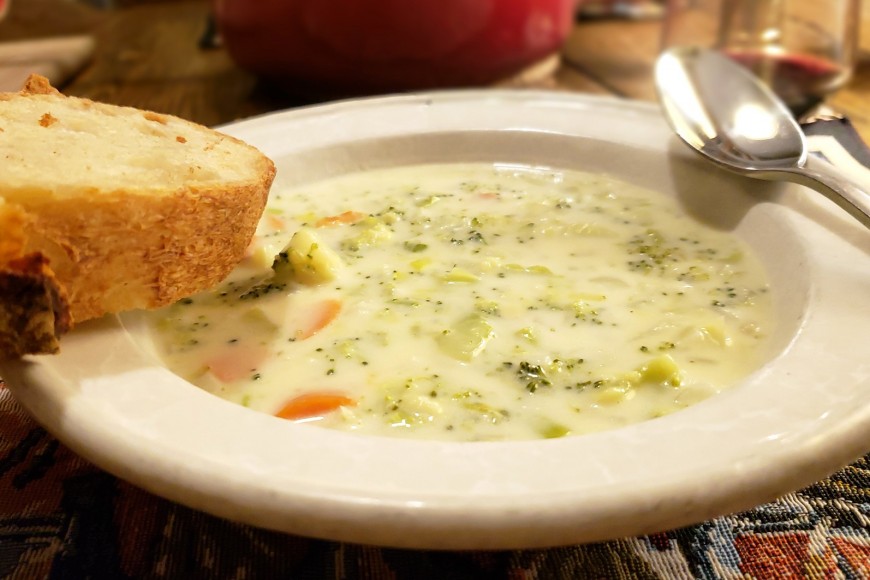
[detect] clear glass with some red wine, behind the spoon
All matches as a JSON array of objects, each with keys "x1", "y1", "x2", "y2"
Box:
[{"x1": 662, "y1": 0, "x2": 860, "y2": 118}]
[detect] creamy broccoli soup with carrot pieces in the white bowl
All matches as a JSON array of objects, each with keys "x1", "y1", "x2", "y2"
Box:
[{"x1": 153, "y1": 164, "x2": 772, "y2": 440}]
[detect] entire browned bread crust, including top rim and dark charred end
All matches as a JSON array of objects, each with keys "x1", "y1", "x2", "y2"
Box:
[{"x1": 0, "y1": 75, "x2": 275, "y2": 356}]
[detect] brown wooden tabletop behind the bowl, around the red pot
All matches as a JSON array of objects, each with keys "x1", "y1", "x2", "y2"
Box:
[{"x1": 0, "y1": 0, "x2": 870, "y2": 141}]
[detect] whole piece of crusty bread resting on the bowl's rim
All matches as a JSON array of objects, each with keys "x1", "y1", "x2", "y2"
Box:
[{"x1": 0, "y1": 76, "x2": 275, "y2": 356}]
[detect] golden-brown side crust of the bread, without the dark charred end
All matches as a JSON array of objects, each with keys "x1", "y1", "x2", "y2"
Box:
[{"x1": 26, "y1": 179, "x2": 271, "y2": 322}]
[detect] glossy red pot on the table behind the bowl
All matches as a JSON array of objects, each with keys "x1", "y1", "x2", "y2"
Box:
[{"x1": 215, "y1": 0, "x2": 576, "y2": 92}]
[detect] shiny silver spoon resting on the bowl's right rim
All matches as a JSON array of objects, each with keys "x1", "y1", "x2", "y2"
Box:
[{"x1": 655, "y1": 47, "x2": 870, "y2": 228}]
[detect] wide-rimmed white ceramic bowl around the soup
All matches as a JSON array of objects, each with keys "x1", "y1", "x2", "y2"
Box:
[{"x1": 0, "y1": 91, "x2": 870, "y2": 549}]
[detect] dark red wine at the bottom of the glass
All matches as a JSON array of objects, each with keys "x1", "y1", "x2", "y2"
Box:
[{"x1": 725, "y1": 49, "x2": 847, "y2": 118}]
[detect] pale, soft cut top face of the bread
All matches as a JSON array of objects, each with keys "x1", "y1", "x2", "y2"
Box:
[{"x1": 0, "y1": 95, "x2": 259, "y2": 195}]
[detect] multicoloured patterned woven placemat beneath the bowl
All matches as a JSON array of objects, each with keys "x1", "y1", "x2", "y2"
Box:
[{"x1": 0, "y1": 381, "x2": 870, "y2": 580}]
